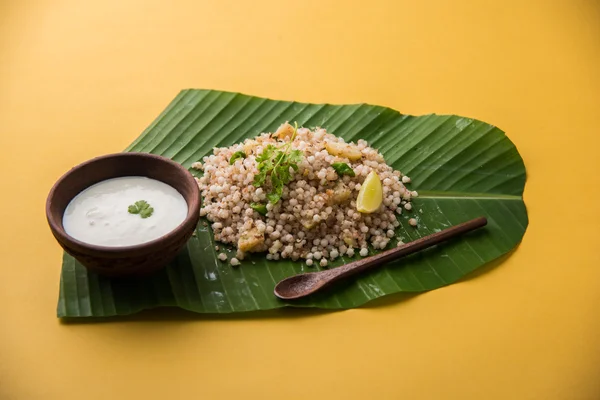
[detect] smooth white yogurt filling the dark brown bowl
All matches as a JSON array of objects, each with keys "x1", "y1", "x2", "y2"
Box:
[{"x1": 63, "y1": 176, "x2": 188, "y2": 247}]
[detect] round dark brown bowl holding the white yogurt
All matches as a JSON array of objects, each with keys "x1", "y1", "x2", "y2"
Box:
[{"x1": 46, "y1": 153, "x2": 200, "y2": 277}]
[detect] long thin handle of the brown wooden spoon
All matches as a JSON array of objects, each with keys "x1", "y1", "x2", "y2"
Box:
[{"x1": 318, "y1": 217, "x2": 487, "y2": 284}]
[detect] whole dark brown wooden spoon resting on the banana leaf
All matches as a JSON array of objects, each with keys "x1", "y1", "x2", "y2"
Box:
[{"x1": 274, "y1": 217, "x2": 487, "y2": 300}]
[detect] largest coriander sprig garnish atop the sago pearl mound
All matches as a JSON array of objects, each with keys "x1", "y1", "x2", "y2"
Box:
[{"x1": 253, "y1": 123, "x2": 303, "y2": 204}]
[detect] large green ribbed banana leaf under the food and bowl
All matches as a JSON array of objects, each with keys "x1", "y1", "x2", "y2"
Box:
[{"x1": 58, "y1": 90, "x2": 528, "y2": 317}]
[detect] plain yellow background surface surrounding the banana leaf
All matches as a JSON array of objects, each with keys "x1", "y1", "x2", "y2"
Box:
[{"x1": 0, "y1": 0, "x2": 600, "y2": 400}]
